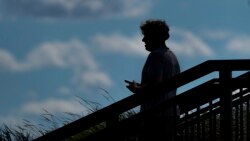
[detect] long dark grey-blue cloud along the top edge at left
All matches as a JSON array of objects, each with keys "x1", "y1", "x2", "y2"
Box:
[{"x1": 0, "y1": 0, "x2": 151, "y2": 19}]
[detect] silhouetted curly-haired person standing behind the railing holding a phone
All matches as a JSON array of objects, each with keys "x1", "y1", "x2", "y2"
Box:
[{"x1": 125, "y1": 20, "x2": 180, "y2": 141}]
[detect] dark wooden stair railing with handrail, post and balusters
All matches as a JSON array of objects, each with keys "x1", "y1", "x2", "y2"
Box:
[{"x1": 35, "y1": 60, "x2": 250, "y2": 141}]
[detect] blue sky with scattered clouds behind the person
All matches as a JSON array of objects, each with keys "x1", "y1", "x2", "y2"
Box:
[{"x1": 0, "y1": 0, "x2": 250, "y2": 124}]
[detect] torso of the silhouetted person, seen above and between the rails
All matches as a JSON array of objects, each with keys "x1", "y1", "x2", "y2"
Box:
[{"x1": 141, "y1": 48, "x2": 180, "y2": 114}]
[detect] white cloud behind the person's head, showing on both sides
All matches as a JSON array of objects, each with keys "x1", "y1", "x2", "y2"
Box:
[{"x1": 94, "y1": 28, "x2": 214, "y2": 57}]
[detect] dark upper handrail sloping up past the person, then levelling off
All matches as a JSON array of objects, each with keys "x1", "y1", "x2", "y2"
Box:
[{"x1": 35, "y1": 59, "x2": 250, "y2": 141}]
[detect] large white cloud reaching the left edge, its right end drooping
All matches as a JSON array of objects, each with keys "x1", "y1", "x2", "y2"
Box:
[{"x1": 0, "y1": 39, "x2": 112, "y2": 87}]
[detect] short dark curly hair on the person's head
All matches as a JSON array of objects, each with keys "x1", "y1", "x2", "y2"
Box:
[{"x1": 140, "y1": 19, "x2": 169, "y2": 40}]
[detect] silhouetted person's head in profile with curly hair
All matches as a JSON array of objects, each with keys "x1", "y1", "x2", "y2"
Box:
[{"x1": 140, "y1": 20, "x2": 169, "y2": 51}]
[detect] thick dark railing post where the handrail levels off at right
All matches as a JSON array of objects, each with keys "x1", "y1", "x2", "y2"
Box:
[{"x1": 219, "y1": 69, "x2": 232, "y2": 141}]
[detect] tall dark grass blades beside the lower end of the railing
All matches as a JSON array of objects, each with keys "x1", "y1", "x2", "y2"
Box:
[{"x1": 0, "y1": 88, "x2": 127, "y2": 141}]
